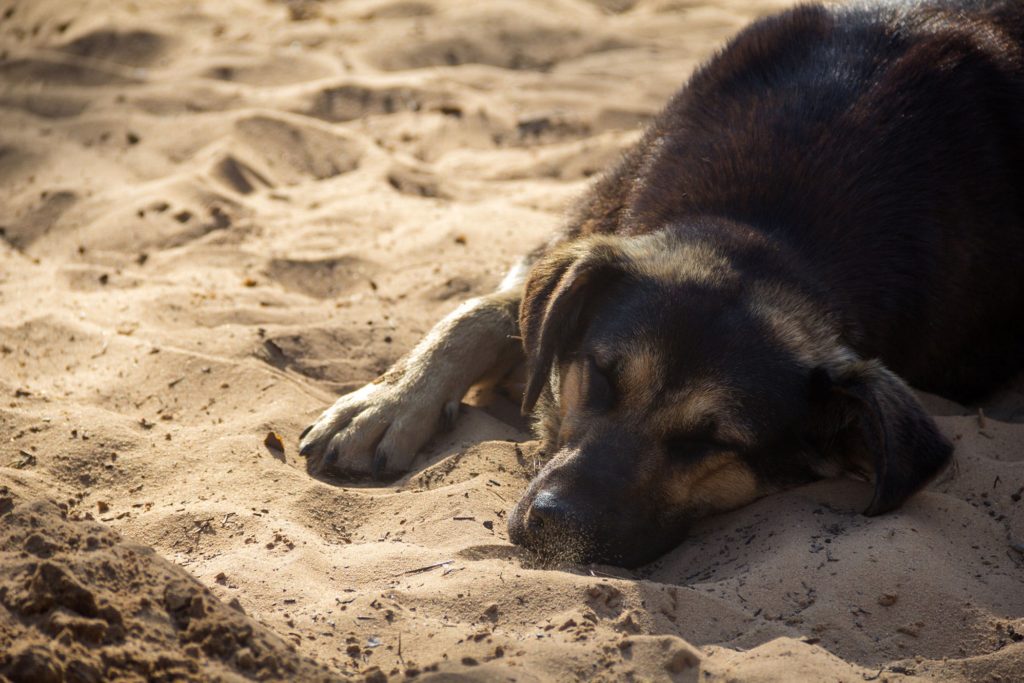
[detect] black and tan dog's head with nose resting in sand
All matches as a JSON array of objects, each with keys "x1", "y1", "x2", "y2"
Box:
[{"x1": 509, "y1": 228, "x2": 951, "y2": 566}]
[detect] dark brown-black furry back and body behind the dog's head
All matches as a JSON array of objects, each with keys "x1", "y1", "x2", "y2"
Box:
[{"x1": 570, "y1": 1, "x2": 1024, "y2": 398}]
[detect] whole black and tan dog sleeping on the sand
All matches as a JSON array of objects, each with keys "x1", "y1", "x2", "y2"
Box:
[{"x1": 302, "y1": 0, "x2": 1024, "y2": 565}]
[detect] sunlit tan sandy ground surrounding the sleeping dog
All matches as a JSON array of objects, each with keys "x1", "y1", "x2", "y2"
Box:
[{"x1": 0, "y1": 0, "x2": 1024, "y2": 681}]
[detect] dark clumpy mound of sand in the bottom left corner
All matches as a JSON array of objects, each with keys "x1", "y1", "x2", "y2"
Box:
[{"x1": 0, "y1": 486, "x2": 338, "y2": 683}]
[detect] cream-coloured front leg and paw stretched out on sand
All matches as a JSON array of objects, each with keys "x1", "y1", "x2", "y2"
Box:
[{"x1": 300, "y1": 261, "x2": 527, "y2": 477}]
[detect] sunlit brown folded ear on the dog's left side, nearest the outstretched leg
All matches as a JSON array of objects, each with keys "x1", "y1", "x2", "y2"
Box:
[{"x1": 519, "y1": 238, "x2": 625, "y2": 414}]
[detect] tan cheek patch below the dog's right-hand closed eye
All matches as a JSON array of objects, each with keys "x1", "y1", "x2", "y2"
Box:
[{"x1": 666, "y1": 453, "x2": 761, "y2": 512}]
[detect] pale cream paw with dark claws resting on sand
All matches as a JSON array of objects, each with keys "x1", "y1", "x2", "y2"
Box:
[{"x1": 299, "y1": 380, "x2": 461, "y2": 479}]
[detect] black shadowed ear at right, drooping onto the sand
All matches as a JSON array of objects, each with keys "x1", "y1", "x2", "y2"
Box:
[{"x1": 810, "y1": 359, "x2": 952, "y2": 516}]
